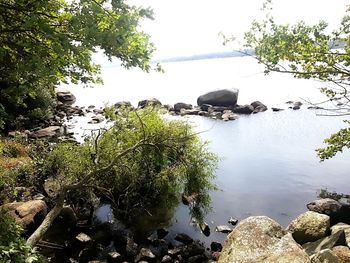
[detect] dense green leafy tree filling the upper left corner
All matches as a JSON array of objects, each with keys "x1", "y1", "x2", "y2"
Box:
[{"x1": 0, "y1": 0, "x2": 154, "y2": 128}]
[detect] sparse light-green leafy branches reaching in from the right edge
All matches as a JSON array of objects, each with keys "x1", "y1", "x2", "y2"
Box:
[{"x1": 245, "y1": 0, "x2": 350, "y2": 160}]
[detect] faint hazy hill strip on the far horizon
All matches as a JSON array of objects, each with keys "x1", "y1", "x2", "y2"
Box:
[{"x1": 154, "y1": 49, "x2": 254, "y2": 63}]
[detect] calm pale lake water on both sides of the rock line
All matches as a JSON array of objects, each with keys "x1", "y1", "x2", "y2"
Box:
[{"x1": 64, "y1": 57, "x2": 350, "y2": 248}]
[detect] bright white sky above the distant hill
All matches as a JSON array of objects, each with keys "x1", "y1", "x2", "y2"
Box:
[{"x1": 129, "y1": 0, "x2": 349, "y2": 58}]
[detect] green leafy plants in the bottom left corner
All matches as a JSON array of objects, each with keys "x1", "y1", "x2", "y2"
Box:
[{"x1": 0, "y1": 210, "x2": 44, "y2": 263}]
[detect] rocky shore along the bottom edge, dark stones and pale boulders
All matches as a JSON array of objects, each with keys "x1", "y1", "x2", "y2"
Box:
[{"x1": 4, "y1": 196, "x2": 350, "y2": 263}]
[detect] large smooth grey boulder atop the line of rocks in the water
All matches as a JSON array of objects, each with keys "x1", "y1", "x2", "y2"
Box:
[{"x1": 197, "y1": 89, "x2": 238, "y2": 107}]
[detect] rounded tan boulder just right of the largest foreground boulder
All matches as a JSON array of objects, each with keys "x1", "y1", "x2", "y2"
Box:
[{"x1": 287, "y1": 211, "x2": 330, "y2": 244}]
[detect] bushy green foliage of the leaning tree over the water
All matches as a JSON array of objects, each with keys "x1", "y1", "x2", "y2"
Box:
[{"x1": 40, "y1": 108, "x2": 217, "y2": 223}]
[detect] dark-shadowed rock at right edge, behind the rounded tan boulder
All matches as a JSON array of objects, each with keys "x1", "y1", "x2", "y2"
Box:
[{"x1": 306, "y1": 198, "x2": 350, "y2": 225}]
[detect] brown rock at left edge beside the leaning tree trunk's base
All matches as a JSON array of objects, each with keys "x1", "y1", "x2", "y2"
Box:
[{"x1": 1, "y1": 200, "x2": 47, "y2": 231}]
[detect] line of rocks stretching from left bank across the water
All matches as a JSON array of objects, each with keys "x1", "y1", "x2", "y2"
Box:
[{"x1": 8, "y1": 89, "x2": 314, "y2": 141}]
